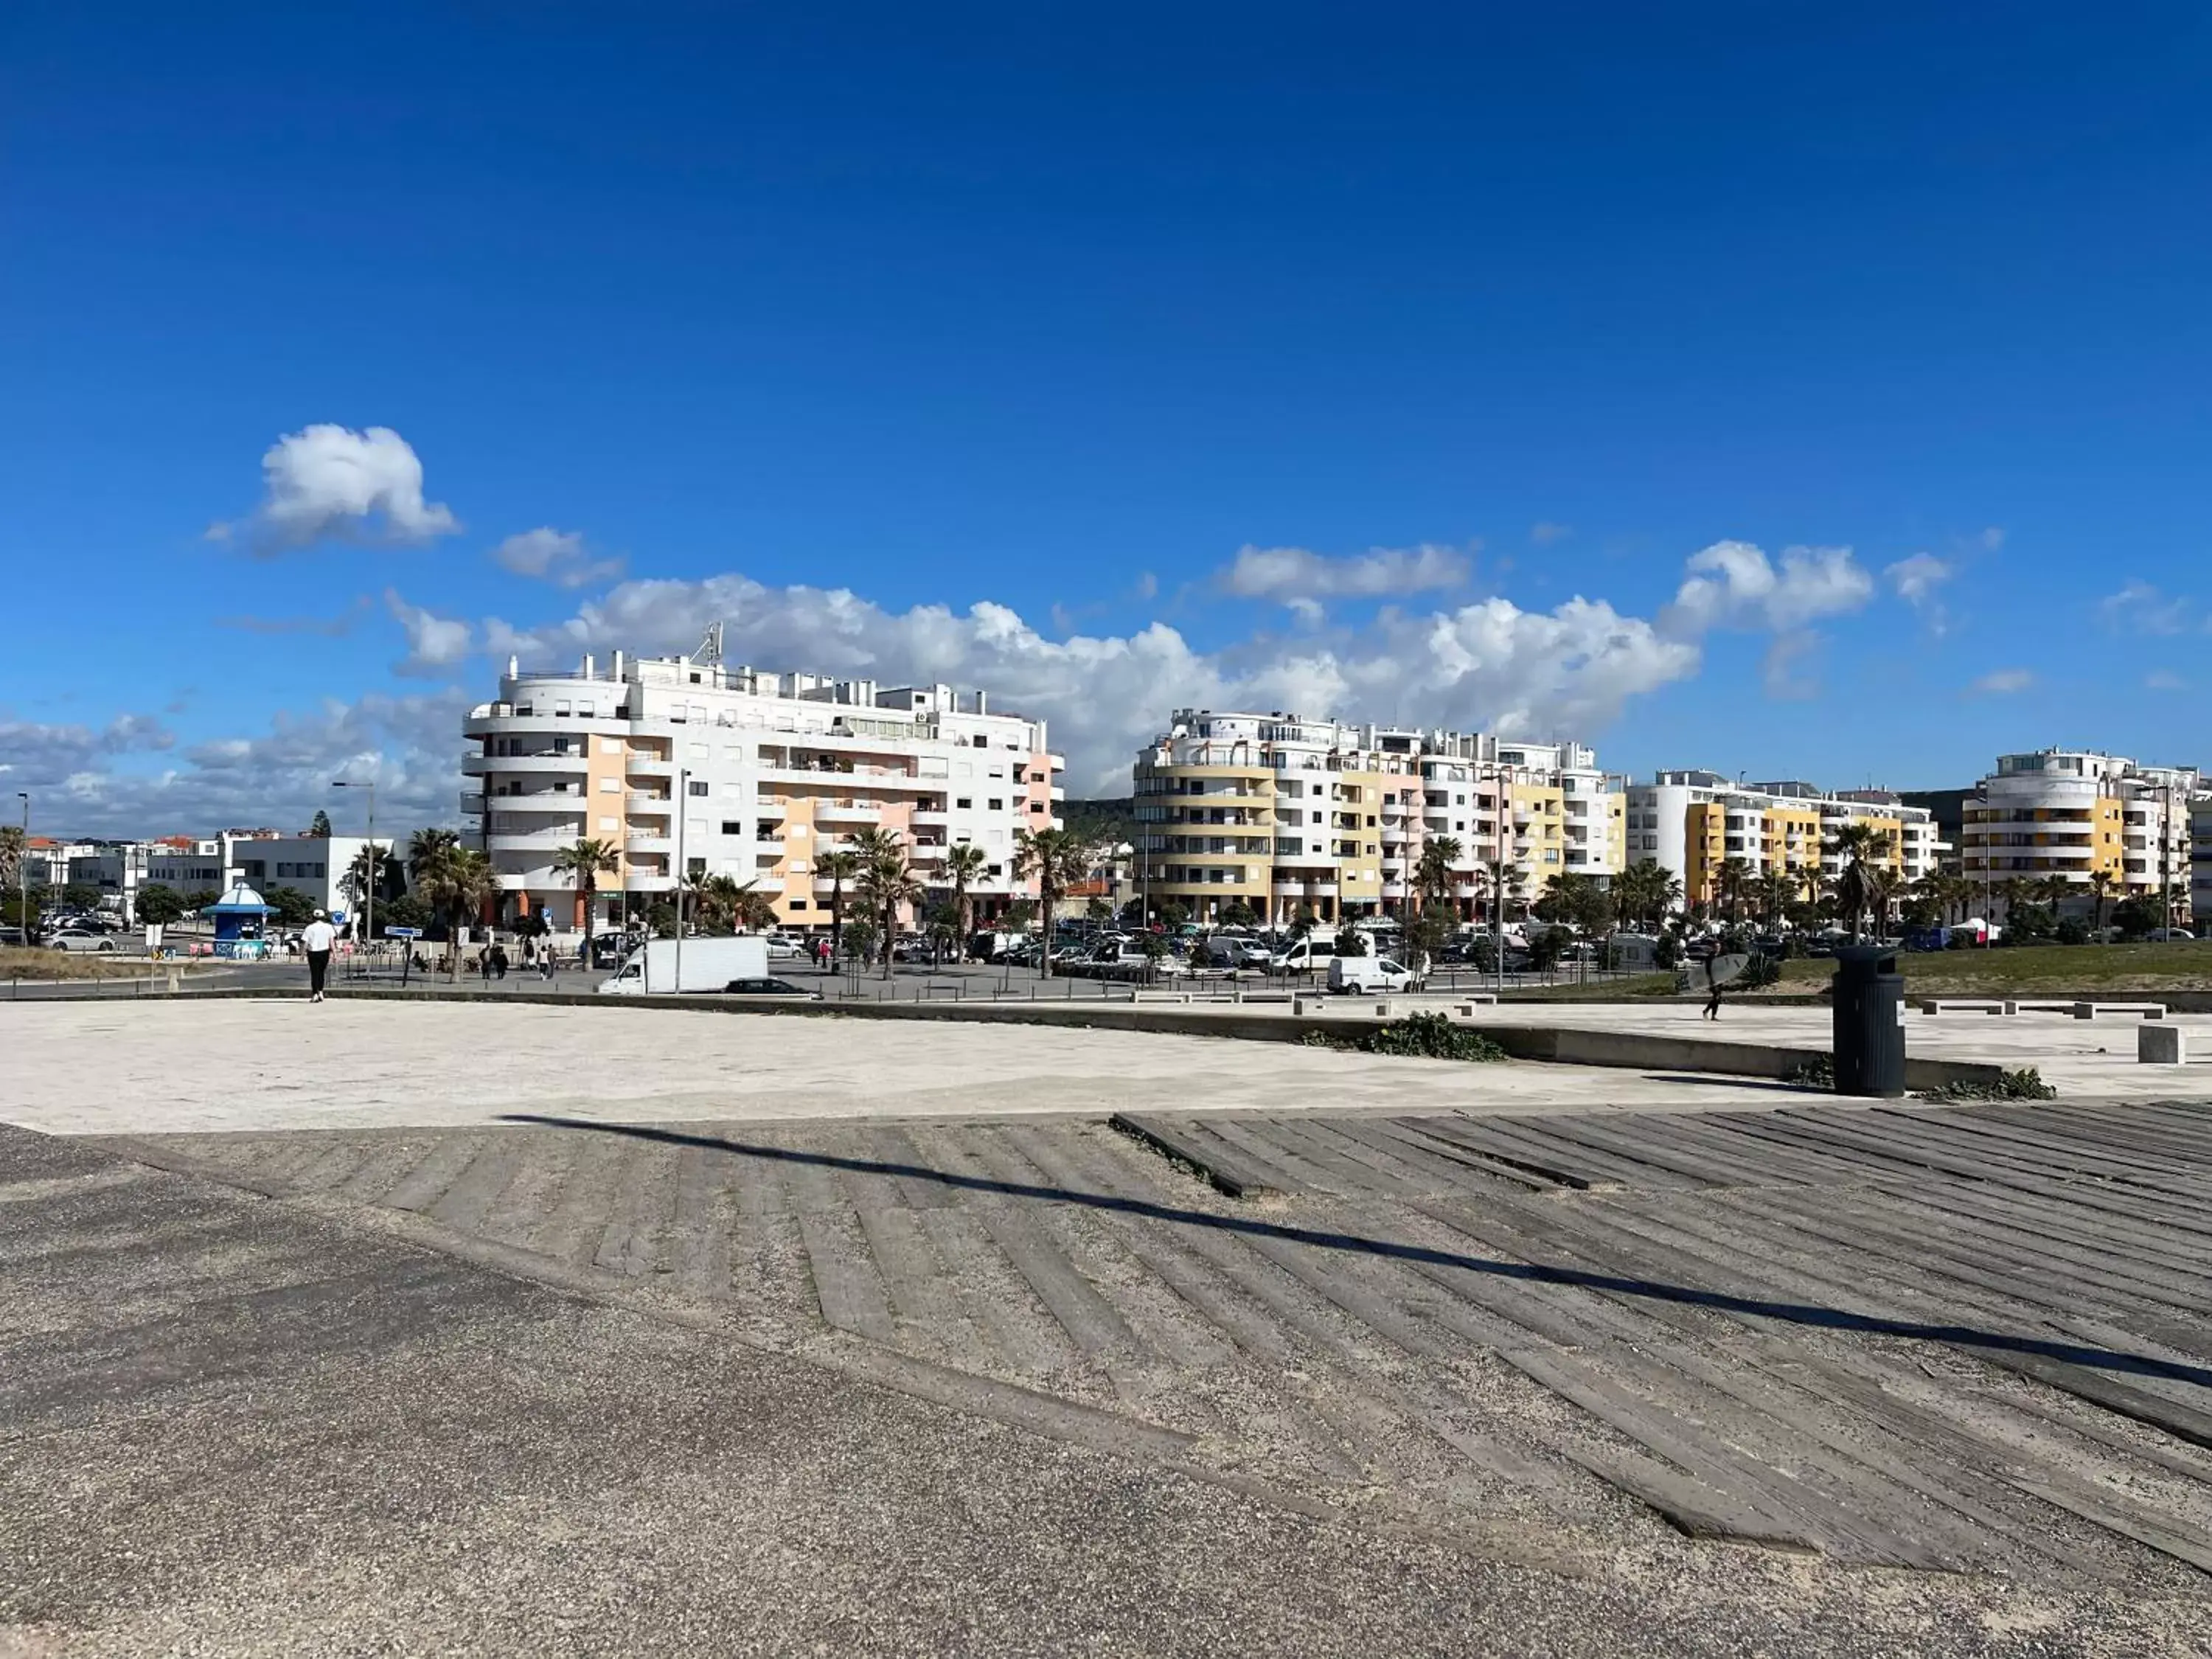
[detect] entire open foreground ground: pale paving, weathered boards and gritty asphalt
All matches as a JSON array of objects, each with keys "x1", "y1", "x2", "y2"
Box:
[{"x1": 0, "y1": 1000, "x2": 2212, "y2": 1659}]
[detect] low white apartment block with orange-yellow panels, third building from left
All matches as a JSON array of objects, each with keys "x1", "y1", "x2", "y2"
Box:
[{"x1": 1626, "y1": 770, "x2": 1944, "y2": 905}]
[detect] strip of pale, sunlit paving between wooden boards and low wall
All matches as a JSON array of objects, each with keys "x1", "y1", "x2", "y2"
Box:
[{"x1": 0, "y1": 1000, "x2": 1832, "y2": 1135}]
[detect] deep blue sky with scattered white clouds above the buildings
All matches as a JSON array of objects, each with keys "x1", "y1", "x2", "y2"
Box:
[{"x1": 0, "y1": 4, "x2": 2212, "y2": 832}]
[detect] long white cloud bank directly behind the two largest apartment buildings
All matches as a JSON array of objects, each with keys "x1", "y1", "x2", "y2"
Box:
[{"x1": 484, "y1": 575, "x2": 1699, "y2": 794}]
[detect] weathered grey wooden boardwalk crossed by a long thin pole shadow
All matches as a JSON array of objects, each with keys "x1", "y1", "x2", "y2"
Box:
[{"x1": 119, "y1": 1102, "x2": 2212, "y2": 1593}]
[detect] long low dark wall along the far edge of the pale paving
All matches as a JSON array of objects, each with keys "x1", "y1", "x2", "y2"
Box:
[{"x1": 156, "y1": 987, "x2": 2004, "y2": 1088}]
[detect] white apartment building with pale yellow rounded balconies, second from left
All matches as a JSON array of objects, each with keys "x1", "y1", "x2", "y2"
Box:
[{"x1": 1133, "y1": 708, "x2": 1621, "y2": 922}]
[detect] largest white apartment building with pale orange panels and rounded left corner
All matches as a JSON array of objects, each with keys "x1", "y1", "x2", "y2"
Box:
[{"x1": 460, "y1": 648, "x2": 1066, "y2": 929}]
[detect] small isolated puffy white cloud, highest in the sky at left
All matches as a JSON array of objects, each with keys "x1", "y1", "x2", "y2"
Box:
[{"x1": 208, "y1": 425, "x2": 460, "y2": 553}]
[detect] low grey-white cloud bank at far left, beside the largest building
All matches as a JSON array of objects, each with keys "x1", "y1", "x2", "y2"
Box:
[{"x1": 0, "y1": 690, "x2": 476, "y2": 836}]
